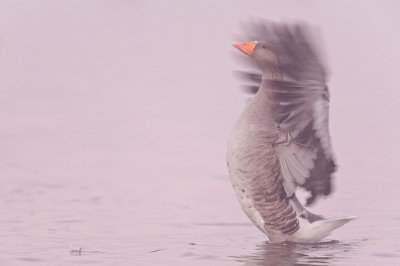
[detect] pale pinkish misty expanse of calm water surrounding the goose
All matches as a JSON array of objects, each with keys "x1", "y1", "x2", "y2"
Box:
[{"x1": 0, "y1": 0, "x2": 400, "y2": 266}]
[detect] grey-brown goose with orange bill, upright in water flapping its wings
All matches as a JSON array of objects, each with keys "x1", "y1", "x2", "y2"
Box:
[{"x1": 227, "y1": 21, "x2": 357, "y2": 243}]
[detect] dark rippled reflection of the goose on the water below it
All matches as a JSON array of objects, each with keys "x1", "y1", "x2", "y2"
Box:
[{"x1": 234, "y1": 240, "x2": 358, "y2": 266}]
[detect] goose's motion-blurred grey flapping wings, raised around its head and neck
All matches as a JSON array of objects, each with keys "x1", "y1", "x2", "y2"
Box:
[{"x1": 234, "y1": 20, "x2": 336, "y2": 204}]
